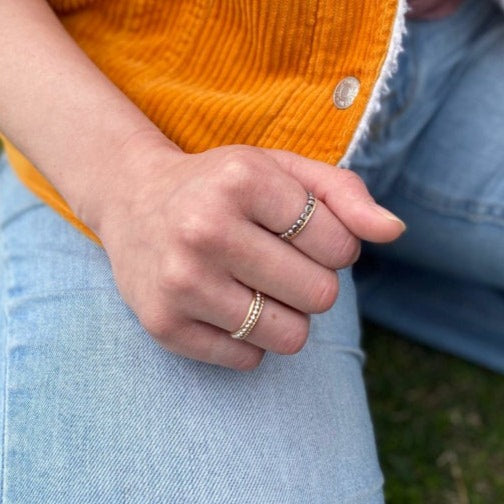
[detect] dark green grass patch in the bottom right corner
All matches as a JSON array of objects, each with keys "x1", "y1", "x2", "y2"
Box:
[{"x1": 364, "y1": 324, "x2": 504, "y2": 504}]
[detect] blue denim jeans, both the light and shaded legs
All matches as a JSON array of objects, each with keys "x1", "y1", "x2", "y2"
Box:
[{"x1": 0, "y1": 0, "x2": 504, "y2": 504}]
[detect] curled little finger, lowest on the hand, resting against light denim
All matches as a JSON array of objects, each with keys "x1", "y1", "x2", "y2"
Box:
[{"x1": 156, "y1": 321, "x2": 264, "y2": 371}]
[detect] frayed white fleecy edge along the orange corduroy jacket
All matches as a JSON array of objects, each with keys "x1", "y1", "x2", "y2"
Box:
[{"x1": 336, "y1": 0, "x2": 412, "y2": 168}]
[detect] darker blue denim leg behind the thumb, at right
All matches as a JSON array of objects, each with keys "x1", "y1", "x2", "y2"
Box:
[{"x1": 351, "y1": 0, "x2": 504, "y2": 372}]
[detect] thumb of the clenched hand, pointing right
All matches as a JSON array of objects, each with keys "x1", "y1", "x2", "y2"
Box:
[{"x1": 262, "y1": 149, "x2": 406, "y2": 243}]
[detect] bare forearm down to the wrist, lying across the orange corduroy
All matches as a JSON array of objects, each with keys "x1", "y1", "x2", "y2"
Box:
[{"x1": 0, "y1": 0, "x2": 179, "y2": 228}]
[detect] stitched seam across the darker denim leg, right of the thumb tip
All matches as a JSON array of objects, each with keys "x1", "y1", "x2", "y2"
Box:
[{"x1": 397, "y1": 176, "x2": 504, "y2": 226}]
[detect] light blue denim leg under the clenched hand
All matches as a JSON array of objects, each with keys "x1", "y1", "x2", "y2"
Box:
[{"x1": 0, "y1": 158, "x2": 383, "y2": 504}]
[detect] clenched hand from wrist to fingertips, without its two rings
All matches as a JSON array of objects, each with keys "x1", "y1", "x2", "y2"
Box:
[{"x1": 95, "y1": 139, "x2": 404, "y2": 370}]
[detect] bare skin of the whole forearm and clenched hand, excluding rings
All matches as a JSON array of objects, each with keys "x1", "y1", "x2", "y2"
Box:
[{"x1": 0, "y1": 0, "x2": 405, "y2": 370}]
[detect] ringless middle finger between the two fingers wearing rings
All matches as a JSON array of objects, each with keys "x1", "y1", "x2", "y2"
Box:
[{"x1": 217, "y1": 221, "x2": 338, "y2": 313}]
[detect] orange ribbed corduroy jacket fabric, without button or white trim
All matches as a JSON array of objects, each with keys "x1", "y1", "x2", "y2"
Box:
[{"x1": 2, "y1": 0, "x2": 397, "y2": 243}]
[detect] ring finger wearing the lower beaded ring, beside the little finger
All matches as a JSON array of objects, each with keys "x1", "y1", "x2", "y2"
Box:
[{"x1": 179, "y1": 277, "x2": 310, "y2": 354}]
